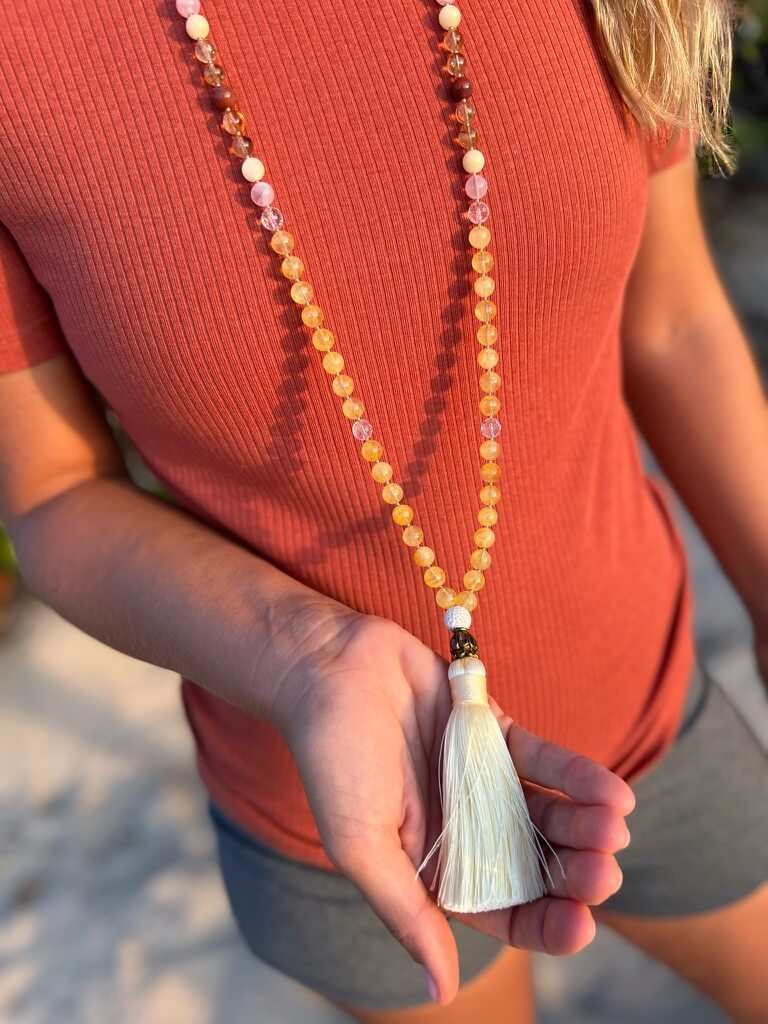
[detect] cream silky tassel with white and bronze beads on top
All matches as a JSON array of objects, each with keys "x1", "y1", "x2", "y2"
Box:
[{"x1": 415, "y1": 608, "x2": 551, "y2": 913}]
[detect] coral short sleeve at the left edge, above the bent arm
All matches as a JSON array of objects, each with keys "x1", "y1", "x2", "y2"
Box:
[{"x1": 0, "y1": 224, "x2": 67, "y2": 373}]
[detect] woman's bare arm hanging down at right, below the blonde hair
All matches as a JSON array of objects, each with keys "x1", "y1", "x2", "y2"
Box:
[{"x1": 623, "y1": 151, "x2": 768, "y2": 667}]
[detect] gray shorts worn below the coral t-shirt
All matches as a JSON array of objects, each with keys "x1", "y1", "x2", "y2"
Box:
[{"x1": 210, "y1": 664, "x2": 768, "y2": 1010}]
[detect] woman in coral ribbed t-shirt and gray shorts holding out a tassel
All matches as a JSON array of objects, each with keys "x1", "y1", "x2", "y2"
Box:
[{"x1": 0, "y1": 0, "x2": 768, "y2": 1022}]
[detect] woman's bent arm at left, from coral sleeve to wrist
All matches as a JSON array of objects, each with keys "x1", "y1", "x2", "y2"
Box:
[{"x1": 0, "y1": 355, "x2": 353, "y2": 720}]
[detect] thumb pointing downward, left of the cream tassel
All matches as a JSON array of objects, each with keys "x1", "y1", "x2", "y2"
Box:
[{"x1": 335, "y1": 838, "x2": 459, "y2": 1004}]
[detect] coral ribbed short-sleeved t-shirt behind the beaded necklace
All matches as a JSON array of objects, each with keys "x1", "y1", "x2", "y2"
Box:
[{"x1": 0, "y1": 0, "x2": 692, "y2": 868}]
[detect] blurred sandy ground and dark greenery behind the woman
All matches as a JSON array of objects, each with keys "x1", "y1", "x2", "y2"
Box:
[{"x1": 0, "y1": 8, "x2": 768, "y2": 1024}]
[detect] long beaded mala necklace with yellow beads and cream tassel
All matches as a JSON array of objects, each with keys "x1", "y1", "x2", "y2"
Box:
[{"x1": 169, "y1": 0, "x2": 551, "y2": 913}]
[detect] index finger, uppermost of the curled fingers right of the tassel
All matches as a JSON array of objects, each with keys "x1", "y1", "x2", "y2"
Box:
[{"x1": 492, "y1": 701, "x2": 635, "y2": 814}]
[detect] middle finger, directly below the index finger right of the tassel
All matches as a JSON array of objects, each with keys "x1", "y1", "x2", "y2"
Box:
[{"x1": 524, "y1": 783, "x2": 630, "y2": 853}]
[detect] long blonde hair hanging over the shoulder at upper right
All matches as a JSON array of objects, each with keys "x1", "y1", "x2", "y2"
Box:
[{"x1": 592, "y1": 0, "x2": 733, "y2": 170}]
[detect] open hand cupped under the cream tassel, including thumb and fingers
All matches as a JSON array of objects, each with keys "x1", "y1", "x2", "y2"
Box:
[{"x1": 271, "y1": 609, "x2": 635, "y2": 1004}]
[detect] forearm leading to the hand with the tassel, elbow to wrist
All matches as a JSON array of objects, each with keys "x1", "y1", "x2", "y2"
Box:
[{"x1": 12, "y1": 477, "x2": 352, "y2": 721}]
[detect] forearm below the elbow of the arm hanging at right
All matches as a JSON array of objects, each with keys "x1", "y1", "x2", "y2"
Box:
[{"x1": 625, "y1": 302, "x2": 768, "y2": 620}]
